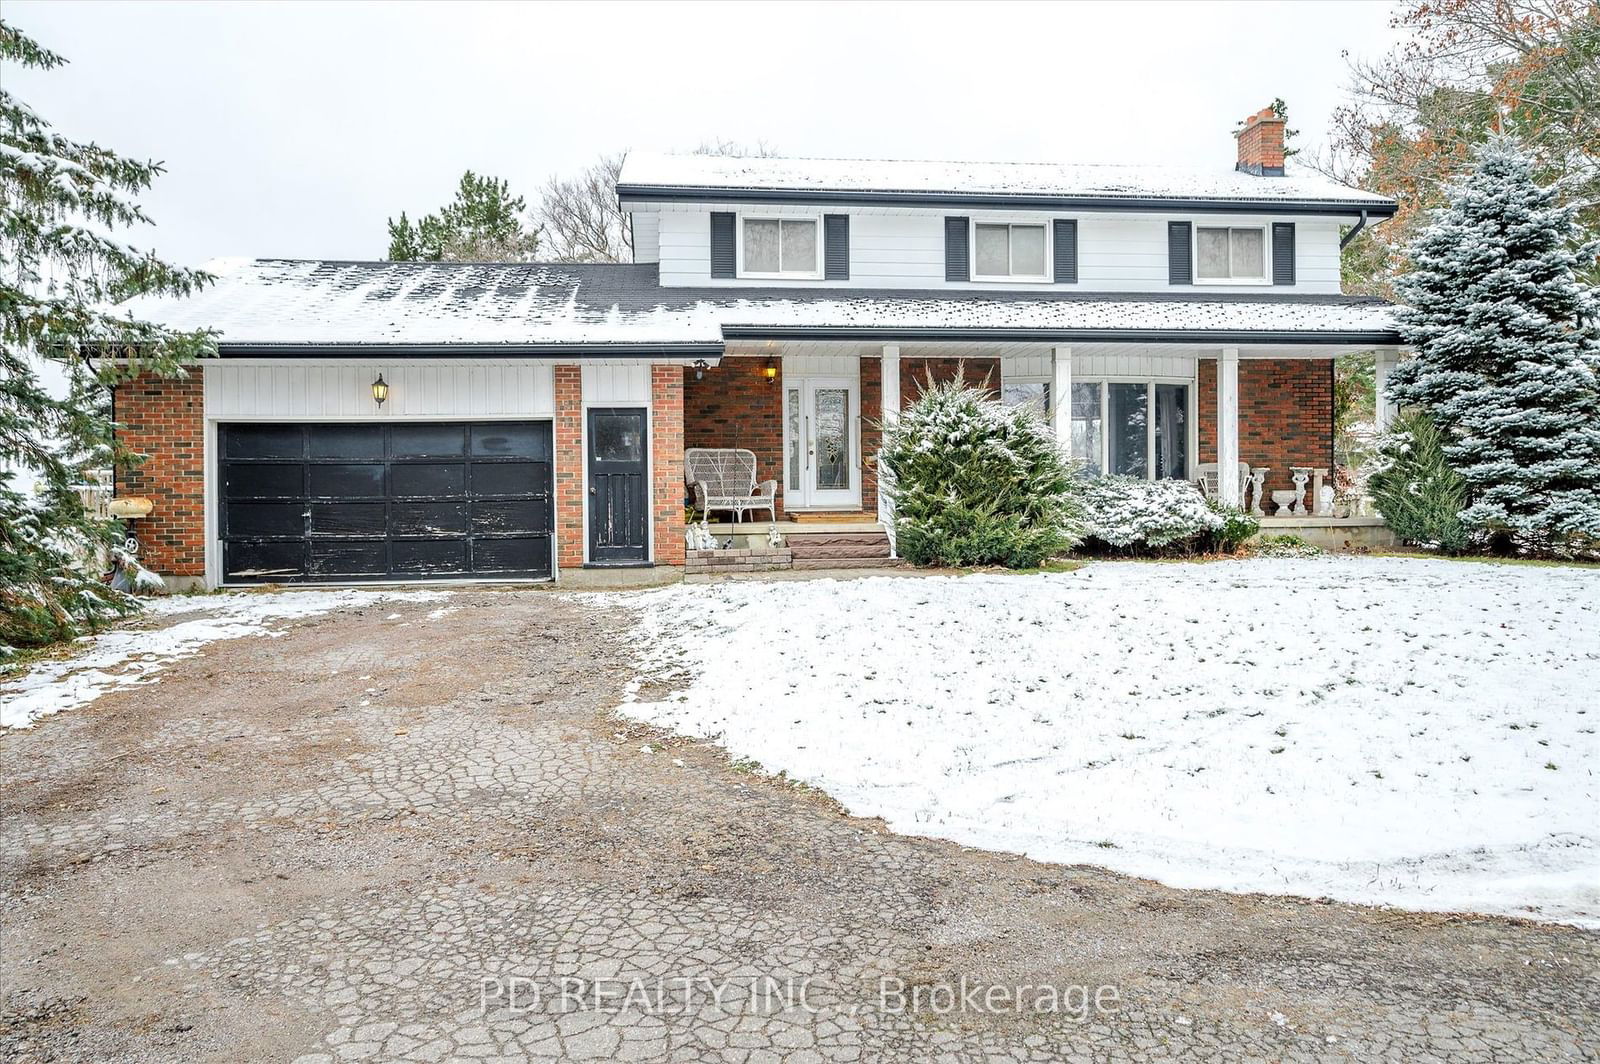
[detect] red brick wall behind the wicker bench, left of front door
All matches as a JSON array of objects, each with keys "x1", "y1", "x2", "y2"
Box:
[{"x1": 675, "y1": 357, "x2": 784, "y2": 520}]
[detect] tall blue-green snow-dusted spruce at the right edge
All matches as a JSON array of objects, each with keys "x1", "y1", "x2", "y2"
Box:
[{"x1": 1389, "y1": 138, "x2": 1600, "y2": 555}]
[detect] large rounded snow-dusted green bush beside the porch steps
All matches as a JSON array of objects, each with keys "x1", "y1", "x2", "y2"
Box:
[{"x1": 882, "y1": 381, "x2": 1083, "y2": 568}]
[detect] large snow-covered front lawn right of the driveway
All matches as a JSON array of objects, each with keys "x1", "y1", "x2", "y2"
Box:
[{"x1": 608, "y1": 558, "x2": 1600, "y2": 926}]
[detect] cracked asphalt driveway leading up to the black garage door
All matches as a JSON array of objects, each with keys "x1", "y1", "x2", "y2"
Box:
[{"x1": 0, "y1": 590, "x2": 1600, "y2": 1064}]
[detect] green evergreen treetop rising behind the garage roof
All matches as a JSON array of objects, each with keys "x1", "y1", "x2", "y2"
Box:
[{"x1": 389, "y1": 170, "x2": 539, "y2": 262}]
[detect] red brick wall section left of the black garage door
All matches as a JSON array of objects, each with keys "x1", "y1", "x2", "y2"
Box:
[{"x1": 114, "y1": 370, "x2": 205, "y2": 576}]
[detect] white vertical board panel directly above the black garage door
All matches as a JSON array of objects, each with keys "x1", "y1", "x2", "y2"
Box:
[{"x1": 203, "y1": 358, "x2": 553, "y2": 421}]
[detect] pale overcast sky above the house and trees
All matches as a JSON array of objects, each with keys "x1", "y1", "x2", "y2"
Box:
[{"x1": 0, "y1": 0, "x2": 1392, "y2": 266}]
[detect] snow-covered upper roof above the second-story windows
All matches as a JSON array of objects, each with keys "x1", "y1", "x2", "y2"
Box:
[{"x1": 618, "y1": 152, "x2": 1394, "y2": 210}]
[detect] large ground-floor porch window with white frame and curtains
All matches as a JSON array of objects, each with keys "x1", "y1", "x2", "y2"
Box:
[{"x1": 1070, "y1": 381, "x2": 1194, "y2": 480}]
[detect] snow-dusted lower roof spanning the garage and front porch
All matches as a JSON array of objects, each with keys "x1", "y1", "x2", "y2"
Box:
[{"x1": 123, "y1": 259, "x2": 1394, "y2": 355}]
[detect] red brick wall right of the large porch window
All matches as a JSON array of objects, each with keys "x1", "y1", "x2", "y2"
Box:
[{"x1": 1198, "y1": 358, "x2": 1333, "y2": 499}]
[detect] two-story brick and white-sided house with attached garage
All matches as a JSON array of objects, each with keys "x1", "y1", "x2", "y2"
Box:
[{"x1": 115, "y1": 105, "x2": 1400, "y2": 586}]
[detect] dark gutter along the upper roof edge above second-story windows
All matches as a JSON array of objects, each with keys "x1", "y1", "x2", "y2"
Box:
[{"x1": 616, "y1": 184, "x2": 1400, "y2": 224}]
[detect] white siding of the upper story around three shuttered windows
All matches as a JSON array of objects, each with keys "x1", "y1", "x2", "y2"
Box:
[{"x1": 634, "y1": 203, "x2": 1354, "y2": 294}]
